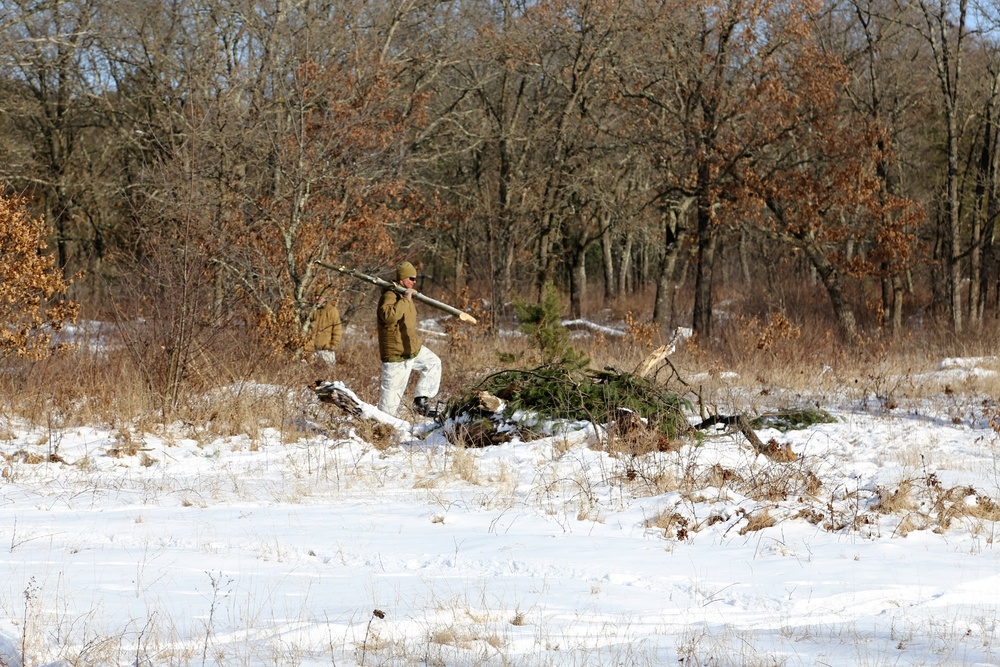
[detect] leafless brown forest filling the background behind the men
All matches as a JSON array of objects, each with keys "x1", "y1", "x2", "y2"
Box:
[{"x1": 0, "y1": 0, "x2": 1000, "y2": 354}]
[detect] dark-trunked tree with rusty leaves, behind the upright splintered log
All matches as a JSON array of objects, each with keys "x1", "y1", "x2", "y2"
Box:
[{"x1": 621, "y1": 0, "x2": 832, "y2": 338}]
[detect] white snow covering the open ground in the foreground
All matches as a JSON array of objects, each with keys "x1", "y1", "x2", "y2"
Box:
[{"x1": 0, "y1": 334, "x2": 1000, "y2": 667}]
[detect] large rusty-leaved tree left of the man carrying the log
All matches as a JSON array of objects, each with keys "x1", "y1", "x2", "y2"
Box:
[{"x1": 101, "y1": 0, "x2": 421, "y2": 349}]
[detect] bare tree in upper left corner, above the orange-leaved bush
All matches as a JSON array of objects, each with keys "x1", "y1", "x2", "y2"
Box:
[{"x1": 0, "y1": 0, "x2": 114, "y2": 282}]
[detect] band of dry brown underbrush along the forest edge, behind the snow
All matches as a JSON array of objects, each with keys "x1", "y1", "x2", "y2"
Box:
[{"x1": 0, "y1": 304, "x2": 1000, "y2": 438}]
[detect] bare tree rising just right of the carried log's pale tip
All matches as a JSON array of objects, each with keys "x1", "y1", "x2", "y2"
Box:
[{"x1": 416, "y1": 1, "x2": 551, "y2": 327}]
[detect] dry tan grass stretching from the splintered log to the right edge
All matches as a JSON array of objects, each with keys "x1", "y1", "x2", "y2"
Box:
[{"x1": 671, "y1": 311, "x2": 1000, "y2": 423}]
